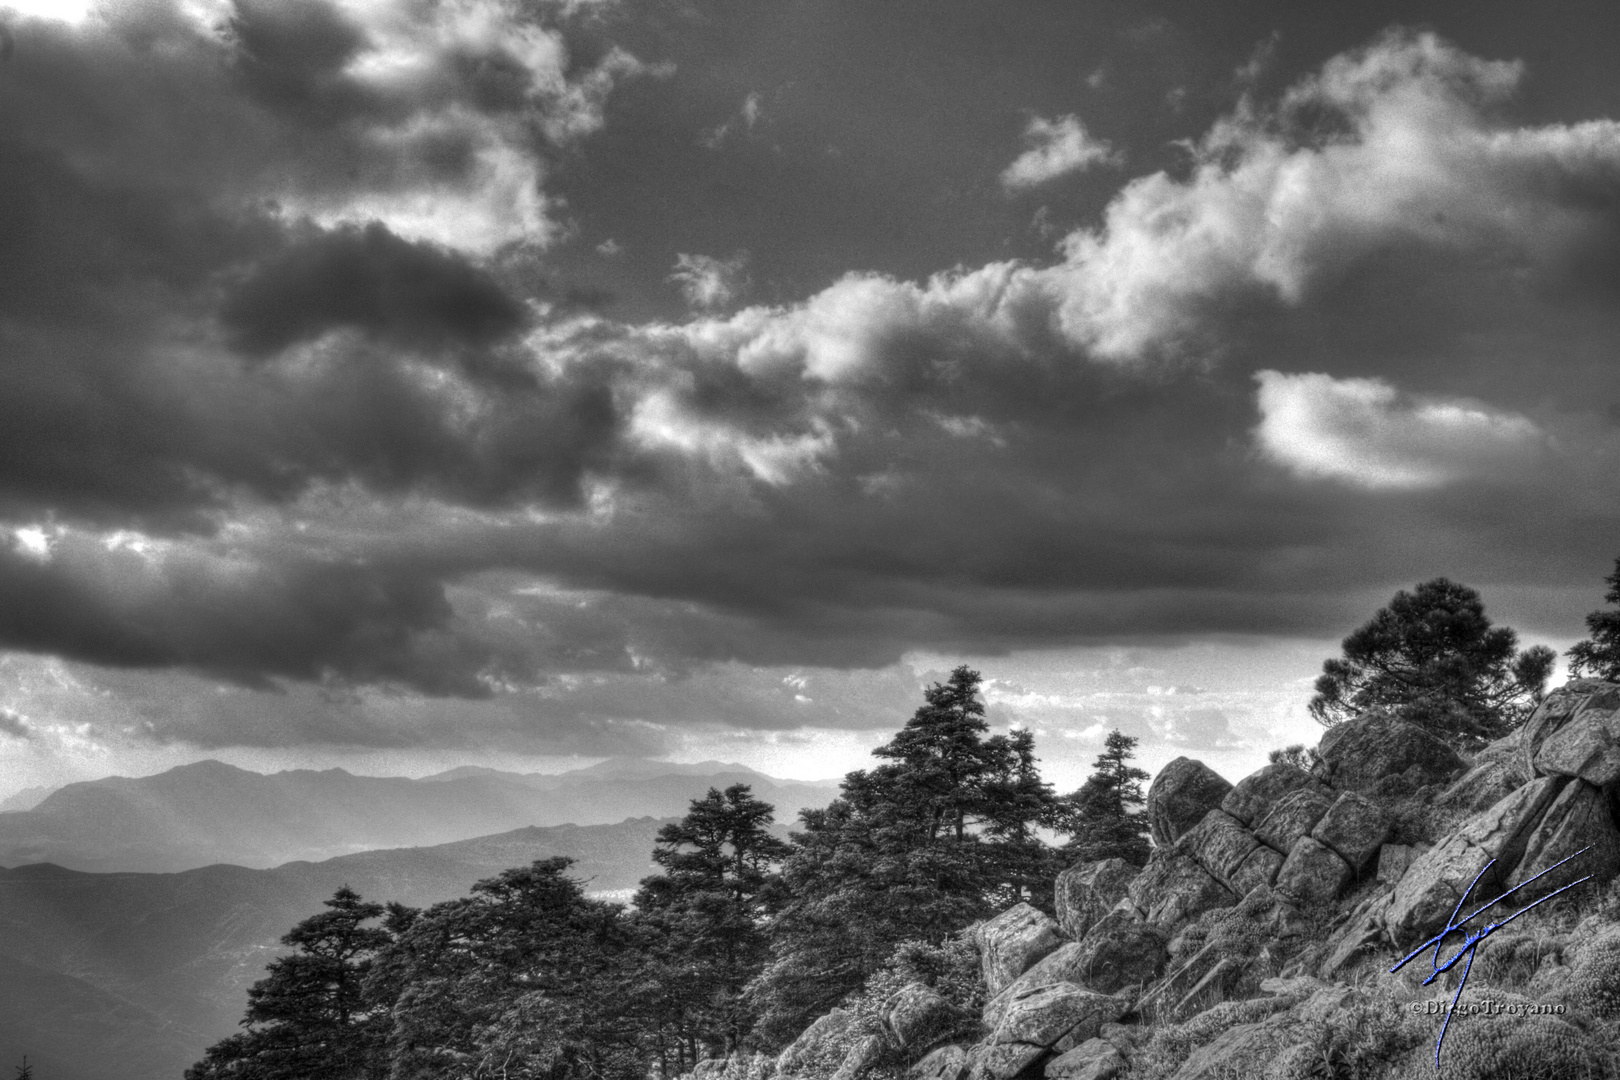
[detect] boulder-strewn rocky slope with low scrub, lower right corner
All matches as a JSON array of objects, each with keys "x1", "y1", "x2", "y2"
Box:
[{"x1": 698, "y1": 680, "x2": 1620, "y2": 1080}]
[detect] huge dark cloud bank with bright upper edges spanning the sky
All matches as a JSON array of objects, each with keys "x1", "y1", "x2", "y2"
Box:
[{"x1": 0, "y1": 12, "x2": 1620, "y2": 745}]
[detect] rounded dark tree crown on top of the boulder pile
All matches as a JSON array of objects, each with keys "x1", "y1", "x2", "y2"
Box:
[{"x1": 1311, "y1": 578, "x2": 1557, "y2": 746}]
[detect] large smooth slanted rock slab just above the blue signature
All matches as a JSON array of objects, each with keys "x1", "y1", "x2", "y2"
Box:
[{"x1": 1388, "y1": 776, "x2": 1567, "y2": 947}]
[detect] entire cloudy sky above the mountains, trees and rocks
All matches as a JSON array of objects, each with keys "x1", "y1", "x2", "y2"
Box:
[{"x1": 0, "y1": 0, "x2": 1620, "y2": 795}]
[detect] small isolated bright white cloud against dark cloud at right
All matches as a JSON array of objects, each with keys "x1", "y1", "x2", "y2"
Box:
[{"x1": 1254, "y1": 371, "x2": 1542, "y2": 487}]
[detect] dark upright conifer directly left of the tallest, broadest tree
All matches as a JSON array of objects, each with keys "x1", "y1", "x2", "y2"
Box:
[{"x1": 635, "y1": 784, "x2": 791, "y2": 1074}]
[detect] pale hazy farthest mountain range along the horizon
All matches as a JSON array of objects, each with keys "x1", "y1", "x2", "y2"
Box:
[{"x1": 0, "y1": 758, "x2": 838, "y2": 873}]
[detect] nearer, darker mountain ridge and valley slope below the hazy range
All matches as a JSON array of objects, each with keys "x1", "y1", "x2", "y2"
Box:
[{"x1": 0, "y1": 819, "x2": 725, "y2": 1080}]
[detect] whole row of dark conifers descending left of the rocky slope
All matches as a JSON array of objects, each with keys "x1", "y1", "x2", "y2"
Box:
[{"x1": 186, "y1": 667, "x2": 1149, "y2": 1080}]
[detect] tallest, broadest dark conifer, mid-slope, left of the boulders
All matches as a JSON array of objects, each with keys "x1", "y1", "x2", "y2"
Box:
[{"x1": 748, "y1": 667, "x2": 1058, "y2": 1046}]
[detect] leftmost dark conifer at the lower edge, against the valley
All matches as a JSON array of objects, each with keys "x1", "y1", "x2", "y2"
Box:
[{"x1": 186, "y1": 886, "x2": 392, "y2": 1080}]
